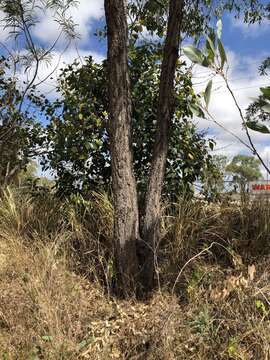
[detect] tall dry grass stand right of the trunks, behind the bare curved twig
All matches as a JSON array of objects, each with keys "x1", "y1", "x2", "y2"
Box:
[{"x1": 160, "y1": 198, "x2": 270, "y2": 288}]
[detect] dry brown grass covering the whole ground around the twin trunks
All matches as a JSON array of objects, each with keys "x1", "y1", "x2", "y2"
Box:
[{"x1": 0, "y1": 190, "x2": 270, "y2": 360}]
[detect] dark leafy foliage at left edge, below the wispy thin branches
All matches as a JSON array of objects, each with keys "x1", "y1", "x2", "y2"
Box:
[{"x1": 0, "y1": 57, "x2": 41, "y2": 186}]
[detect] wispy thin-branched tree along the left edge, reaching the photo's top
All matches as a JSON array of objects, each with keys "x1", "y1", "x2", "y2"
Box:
[{"x1": 0, "y1": 0, "x2": 76, "y2": 185}]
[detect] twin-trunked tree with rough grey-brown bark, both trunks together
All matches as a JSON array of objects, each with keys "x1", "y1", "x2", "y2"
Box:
[{"x1": 105, "y1": 0, "x2": 183, "y2": 292}]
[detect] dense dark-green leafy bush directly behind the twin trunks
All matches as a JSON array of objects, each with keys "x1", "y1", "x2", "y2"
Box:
[{"x1": 43, "y1": 46, "x2": 217, "y2": 195}]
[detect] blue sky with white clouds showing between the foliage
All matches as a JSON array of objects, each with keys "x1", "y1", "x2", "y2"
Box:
[{"x1": 0, "y1": 0, "x2": 270, "y2": 176}]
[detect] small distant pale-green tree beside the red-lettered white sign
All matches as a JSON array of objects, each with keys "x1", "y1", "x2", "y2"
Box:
[{"x1": 226, "y1": 155, "x2": 262, "y2": 194}]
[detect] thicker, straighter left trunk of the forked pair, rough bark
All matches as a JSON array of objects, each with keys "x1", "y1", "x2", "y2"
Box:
[{"x1": 105, "y1": 0, "x2": 139, "y2": 296}]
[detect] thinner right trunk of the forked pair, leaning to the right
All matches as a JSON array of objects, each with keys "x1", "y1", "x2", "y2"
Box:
[{"x1": 141, "y1": 0, "x2": 184, "y2": 290}]
